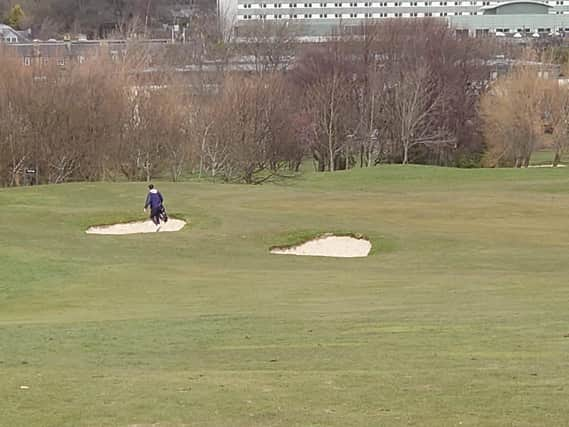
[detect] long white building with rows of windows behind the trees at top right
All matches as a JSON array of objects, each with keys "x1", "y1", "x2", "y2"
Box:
[{"x1": 218, "y1": 0, "x2": 569, "y2": 36}]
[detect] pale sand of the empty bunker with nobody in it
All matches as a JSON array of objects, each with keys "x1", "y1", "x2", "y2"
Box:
[{"x1": 271, "y1": 236, "x2": 371, "y2": 258}]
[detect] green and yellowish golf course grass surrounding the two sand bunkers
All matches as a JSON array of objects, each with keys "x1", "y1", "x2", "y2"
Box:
[{"x1": 0, "y1": 166, "x2": 569, "y2": 427}]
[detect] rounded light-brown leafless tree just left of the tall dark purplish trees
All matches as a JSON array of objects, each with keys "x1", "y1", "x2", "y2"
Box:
[{"x1": 195, "y1": 76, "x2": 297, "y2": 184}]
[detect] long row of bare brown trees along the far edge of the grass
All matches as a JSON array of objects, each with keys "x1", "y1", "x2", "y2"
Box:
[{"x1": 0, "y1": 20, "x2": 569, "y2": 186}]
